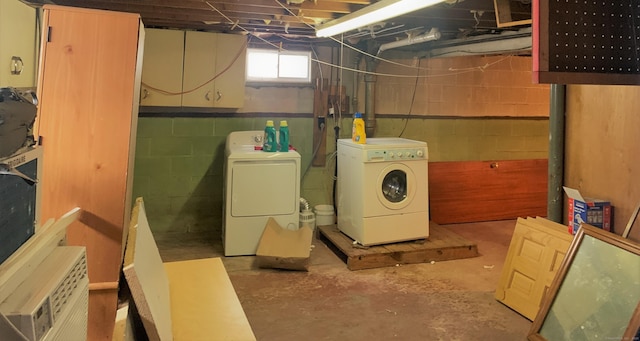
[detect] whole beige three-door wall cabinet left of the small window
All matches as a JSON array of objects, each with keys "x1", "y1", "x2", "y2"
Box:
[{"x1": 140, "y1": 30, "x2": 246, "y2": 108}]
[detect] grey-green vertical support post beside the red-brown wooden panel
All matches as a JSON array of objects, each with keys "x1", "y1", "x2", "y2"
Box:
[{"x1": 547, "y1": 84, "x2": 566, "y2": 224}]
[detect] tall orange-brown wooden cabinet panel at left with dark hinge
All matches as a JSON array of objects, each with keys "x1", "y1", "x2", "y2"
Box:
[{"x1": 36, "y1": 6, "x2": 140, "y2": 340}]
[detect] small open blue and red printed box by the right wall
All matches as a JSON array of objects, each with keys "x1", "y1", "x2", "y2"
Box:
[{"x1": 563, "y1": 187, "x2": 613, "y2": 234}]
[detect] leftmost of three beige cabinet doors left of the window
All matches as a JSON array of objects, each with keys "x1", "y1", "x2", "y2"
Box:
[{"x1": 140, "y1": 29, "x2": 184, "y2": 107}]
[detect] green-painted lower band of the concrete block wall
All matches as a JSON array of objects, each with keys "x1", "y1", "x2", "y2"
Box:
[{"x1": 133, "y1": 115, "x2": 548, "y2": 232}]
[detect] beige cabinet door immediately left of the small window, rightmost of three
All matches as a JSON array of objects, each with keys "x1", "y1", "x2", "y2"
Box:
[{"x1": 215, "y1": 34, "x2": 247, "y2": 108}]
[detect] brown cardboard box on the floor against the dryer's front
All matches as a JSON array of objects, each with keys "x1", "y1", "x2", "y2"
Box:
[{"x1": 256, "y1": 218, "x2": 313, "y2": 271}]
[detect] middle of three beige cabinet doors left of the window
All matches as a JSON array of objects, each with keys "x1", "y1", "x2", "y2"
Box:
[{"x1": 182, "y1": 31, "x2": 218, "y2": 108}]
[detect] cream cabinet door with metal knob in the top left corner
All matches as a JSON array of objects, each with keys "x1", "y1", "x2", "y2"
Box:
[{"x1": 0, "y1": 0, "x2": 38, "y2": 88}]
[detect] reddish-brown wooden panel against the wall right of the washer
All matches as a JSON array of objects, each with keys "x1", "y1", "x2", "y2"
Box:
[{"x1": 429, "y1": 159, "x2": 548, "y2": 224}]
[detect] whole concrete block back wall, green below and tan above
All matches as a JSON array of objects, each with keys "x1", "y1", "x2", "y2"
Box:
[{"x1": 133, "y1": 57, "x2": 549, "y2": 232}]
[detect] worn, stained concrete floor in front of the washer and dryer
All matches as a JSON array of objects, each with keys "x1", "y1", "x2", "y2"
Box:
[{"x1": 155, "y1": 220, "x2": 531, "y2": 341}]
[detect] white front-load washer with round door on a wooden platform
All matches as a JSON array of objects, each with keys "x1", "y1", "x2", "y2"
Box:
[{"x1": 336, "y1": 138, "x2": 429, "y2": 245}]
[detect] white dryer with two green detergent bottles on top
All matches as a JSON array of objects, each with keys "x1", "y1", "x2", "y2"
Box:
[{"x1": 222, "y1": 131, "x2": 300, "y2": 256}]
